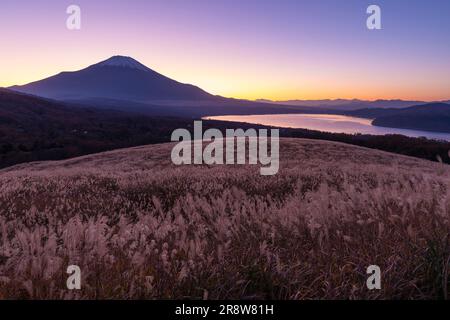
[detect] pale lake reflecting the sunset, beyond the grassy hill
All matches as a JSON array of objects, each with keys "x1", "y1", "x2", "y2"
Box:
[{"x1": 204, "y1": 114, "x2": 450, "y2": 141}]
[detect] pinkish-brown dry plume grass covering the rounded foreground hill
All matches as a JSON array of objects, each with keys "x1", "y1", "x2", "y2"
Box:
[{"x1": 0, "y1": 139, "x2": 450, "y2": 299}]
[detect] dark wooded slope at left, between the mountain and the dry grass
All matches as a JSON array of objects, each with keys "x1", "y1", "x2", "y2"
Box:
[{"x1": 0, "y1": 89, "x2": 206, "y2": 168}]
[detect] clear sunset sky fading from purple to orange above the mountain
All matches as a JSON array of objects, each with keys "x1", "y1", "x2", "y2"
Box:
[{"x1": 0, "y1": 0, "x2": 450, "y2": 101}]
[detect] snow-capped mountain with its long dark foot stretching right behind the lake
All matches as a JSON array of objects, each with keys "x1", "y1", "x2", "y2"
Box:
[{"x1": 9, "y1": 56, "x2": 320, "y2": 117}]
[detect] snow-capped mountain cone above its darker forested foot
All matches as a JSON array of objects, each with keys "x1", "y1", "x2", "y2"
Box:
[{"x1": 10, "y1": 56, "x2": 219, "y2": 102}]
